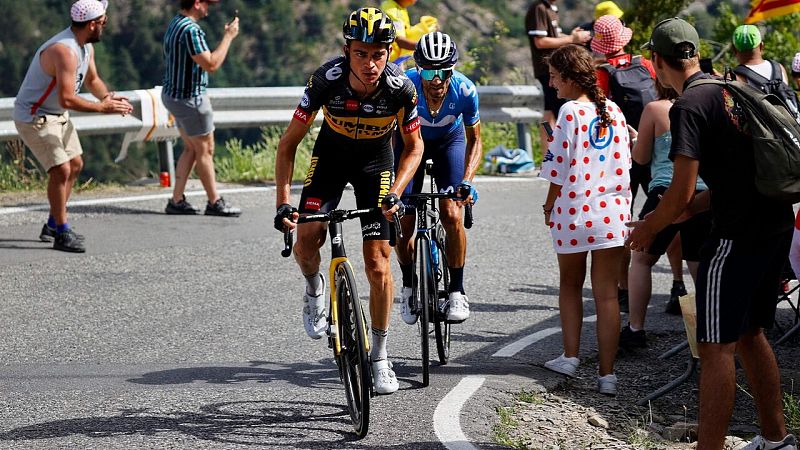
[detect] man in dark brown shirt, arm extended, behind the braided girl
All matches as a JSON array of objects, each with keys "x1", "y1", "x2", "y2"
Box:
[{"x1": 525, "y1": 0, "x2": 591, "y2": 156}]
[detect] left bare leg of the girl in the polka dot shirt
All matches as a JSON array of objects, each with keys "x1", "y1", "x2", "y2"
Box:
[{"x1": 557, "y1": 252, "x2": 588, "y2": 358}]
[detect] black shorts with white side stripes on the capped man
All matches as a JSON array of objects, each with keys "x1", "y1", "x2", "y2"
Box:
[{"x1": 696, "y1": 231, "x2": 792, "y2": 344}]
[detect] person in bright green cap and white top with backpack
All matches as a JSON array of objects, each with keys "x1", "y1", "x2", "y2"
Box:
[{"x1": 733, "y1": 25, "x2": 800, "y2": 118}]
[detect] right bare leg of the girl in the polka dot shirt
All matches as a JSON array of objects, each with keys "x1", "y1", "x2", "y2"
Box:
[{"x1": 591, "y1": 247, "x2": 624, "y2": 376}]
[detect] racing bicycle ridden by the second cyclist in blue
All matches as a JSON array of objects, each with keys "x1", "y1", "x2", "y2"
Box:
[{"x1": 403, "y1": 162, "x2": 473, "y2": 386}]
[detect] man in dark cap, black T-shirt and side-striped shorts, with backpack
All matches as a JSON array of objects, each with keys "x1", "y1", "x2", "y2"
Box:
[{"x1": 627, "y1": 18, "x2": 800, "y2": 450}]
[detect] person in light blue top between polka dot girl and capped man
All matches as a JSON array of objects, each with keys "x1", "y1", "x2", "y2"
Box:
[{"x1": 619, "y1": 80, "x2": 711, "y2": 348}]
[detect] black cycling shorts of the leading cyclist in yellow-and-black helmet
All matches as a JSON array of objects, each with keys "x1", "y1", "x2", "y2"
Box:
[{"x1": 297, "y1": 135, "x2": 394, "y2": 241}]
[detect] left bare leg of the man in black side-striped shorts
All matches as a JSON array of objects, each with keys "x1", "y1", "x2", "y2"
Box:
[{"x1": 697, "y1": 342, "x2": 736, "y2": 450}]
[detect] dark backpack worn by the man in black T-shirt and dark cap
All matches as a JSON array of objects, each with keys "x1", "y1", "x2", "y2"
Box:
[{"x1": 687, "y1": 78, "x2": 800, "y2": 203}]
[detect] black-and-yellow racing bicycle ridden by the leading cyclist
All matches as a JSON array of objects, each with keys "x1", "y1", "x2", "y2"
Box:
[{"x1": 281, "y1": 208, "x2": 400, "y2": 438}]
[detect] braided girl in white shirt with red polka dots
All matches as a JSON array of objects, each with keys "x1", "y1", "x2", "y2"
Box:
[{"x1": 541, "y1": 45, "x2": 631, "y2": 395}]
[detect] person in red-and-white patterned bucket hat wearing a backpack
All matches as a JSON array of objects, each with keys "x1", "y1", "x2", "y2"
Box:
[{"x1": 591, "y1": 14, "x2": 658, "y2": 312}]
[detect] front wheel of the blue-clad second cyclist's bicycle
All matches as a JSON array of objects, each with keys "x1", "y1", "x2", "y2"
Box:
[{"x1": 414, "y1": 237, "x2": 435, "y2": 386}]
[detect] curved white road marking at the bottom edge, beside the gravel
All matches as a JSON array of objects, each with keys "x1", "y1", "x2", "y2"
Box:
[{"x1": 433, "y1": 376, "x2": 486, "y2": 450}]
